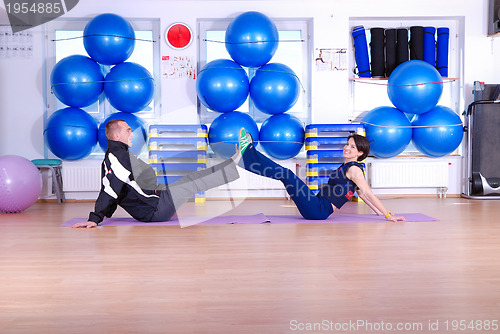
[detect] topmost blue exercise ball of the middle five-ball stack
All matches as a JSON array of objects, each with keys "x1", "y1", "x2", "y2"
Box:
[{"x1": 225, "y1": 12, "x2": 279, "y2": 67}]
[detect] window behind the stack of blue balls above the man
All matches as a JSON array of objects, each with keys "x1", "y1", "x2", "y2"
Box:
[{"x1": 44, "y1": 19, "x2": 161, "y2": 156}]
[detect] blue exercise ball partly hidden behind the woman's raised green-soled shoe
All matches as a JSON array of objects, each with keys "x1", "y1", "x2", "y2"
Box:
[{"x1": 208, "y1": 111, "x2": 259, "y2": 159}]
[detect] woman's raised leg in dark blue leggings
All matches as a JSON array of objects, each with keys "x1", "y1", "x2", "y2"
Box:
[{"x1": 243, "y1": 145, "x2": 333, "y2": 220}]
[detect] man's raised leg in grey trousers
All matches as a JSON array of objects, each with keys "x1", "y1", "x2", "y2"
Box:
[{"x1": 151, "y1": 159, "x2": 240, "y2": 221}]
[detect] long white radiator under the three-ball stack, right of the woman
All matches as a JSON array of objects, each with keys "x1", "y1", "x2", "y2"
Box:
[{"x1": 368, "y1": 161, "x2": 449, "y2": 188}]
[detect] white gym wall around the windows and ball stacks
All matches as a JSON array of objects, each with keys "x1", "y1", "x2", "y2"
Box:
[{"x1": 0, "y1": 0, "x2": 500, "y2": 197}]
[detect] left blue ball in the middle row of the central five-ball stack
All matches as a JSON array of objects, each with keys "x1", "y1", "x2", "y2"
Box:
[{"x1": 196, "y1": 59, "x2": 249, "y2": 113}]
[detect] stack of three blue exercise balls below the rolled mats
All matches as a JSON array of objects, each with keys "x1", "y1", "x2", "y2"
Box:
[{"x1": 361, "y1": 60, "x2": 463, "y2": 158}]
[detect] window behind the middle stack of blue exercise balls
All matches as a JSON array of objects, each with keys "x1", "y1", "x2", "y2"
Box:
[{"x1": 198, "y1": 19, "x2": 312, "y2": 123}]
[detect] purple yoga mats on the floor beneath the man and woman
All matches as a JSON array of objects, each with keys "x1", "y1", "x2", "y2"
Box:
[{"x1": 61, "y1": 213, "x2": 438, "y2": 226}]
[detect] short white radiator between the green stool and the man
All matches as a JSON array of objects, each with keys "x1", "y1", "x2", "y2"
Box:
[{"x1": 62, "y1": 164, "x2": 101, "y2": 192}]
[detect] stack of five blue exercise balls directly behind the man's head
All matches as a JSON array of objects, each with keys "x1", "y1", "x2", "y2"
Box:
[{"x1": 44, "y1": 14, "x2": 154, "y2": 160}]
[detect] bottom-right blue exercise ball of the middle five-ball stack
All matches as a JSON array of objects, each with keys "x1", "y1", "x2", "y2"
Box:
[{"x1": 259, "y1": 114, "x2": 304, "y2": 159}]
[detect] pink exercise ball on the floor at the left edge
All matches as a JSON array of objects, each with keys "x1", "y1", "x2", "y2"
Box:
[{"x1": 0, "y1": 155, "x2": 42, "y2": 213}]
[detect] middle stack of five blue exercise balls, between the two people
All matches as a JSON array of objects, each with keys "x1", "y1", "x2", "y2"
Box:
[{"x1": 196, "y1": 11, "x2": 304, "y2": 159}]
